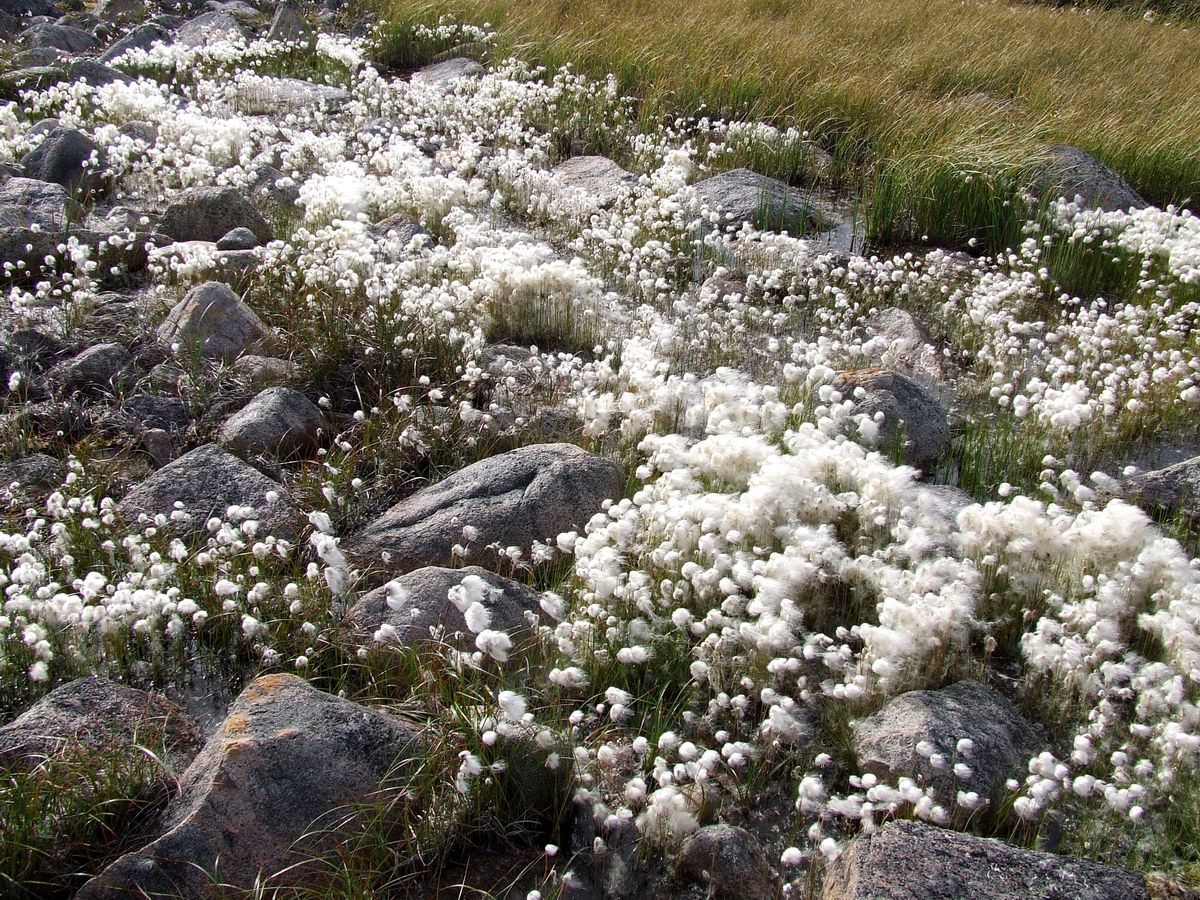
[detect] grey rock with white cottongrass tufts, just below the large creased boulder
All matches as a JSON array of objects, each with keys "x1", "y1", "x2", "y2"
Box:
[{"x1": 347, "y1": 565, "x2": 545, "y2": 650}]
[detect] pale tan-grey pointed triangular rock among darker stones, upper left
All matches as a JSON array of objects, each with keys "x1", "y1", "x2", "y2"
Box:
[{"x1": 158, "y1": 281, "x2": 268, "y2": 362}]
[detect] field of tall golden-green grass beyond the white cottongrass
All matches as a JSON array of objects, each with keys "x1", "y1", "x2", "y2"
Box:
[{"x1": 369, "y1": 0, "x2": 1200, "y2": 247}]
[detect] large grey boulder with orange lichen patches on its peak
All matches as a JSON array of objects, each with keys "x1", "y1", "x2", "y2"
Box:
[{"x1": 77, "y1": 674, "x2": 418, "y2": 900}]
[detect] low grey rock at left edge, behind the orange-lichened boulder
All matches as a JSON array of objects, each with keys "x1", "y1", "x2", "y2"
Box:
[{"x1": 0, "y1": 678, "x2": 200, "y2": 764}]
